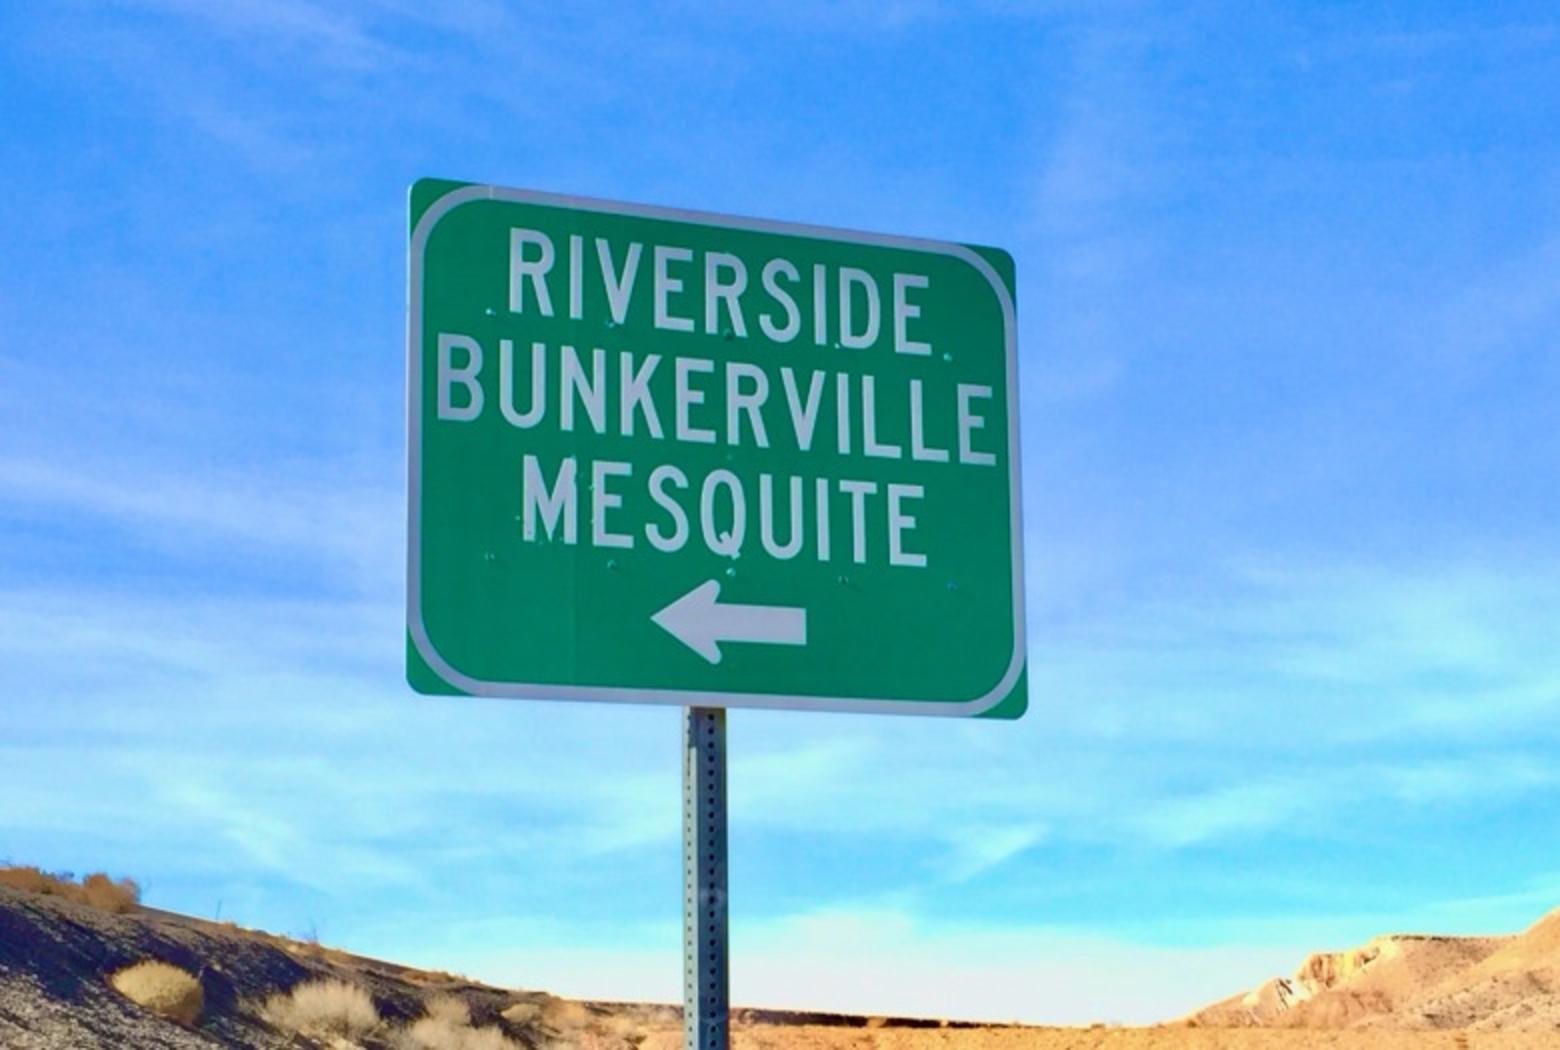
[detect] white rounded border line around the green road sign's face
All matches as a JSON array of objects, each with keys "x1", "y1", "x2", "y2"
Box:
[{"x1": 406, "y1": 186, "x2": 1028, "y2": 718}]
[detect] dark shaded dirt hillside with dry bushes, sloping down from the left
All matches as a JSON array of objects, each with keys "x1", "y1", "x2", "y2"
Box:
[{"x1": 0, "y1": 880, "x2": 985, "y2": 1050}]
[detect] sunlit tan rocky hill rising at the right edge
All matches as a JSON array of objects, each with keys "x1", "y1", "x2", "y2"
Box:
[{"x1": 1189, "y1": 911, "x2": 1560, "y2": 1033}]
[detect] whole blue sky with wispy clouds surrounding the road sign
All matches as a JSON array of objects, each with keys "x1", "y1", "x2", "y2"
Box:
[{"x1": 0, "y1": 0, "x2": 1560, "y2": 1022}]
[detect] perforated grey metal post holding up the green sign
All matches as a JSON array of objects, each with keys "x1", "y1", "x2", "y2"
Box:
[{"x1": 683, "y1": 707, "x2": 730, "y2": 1050}]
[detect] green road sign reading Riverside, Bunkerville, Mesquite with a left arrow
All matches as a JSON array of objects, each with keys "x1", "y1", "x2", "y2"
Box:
[{"x1": 407, "y1": 179, "x2": 1026, "y2": 718}]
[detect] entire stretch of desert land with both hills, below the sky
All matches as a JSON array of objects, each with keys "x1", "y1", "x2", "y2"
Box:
[{"x1": 0, "y1": 880, "x2": 1560, "y2": 1050}]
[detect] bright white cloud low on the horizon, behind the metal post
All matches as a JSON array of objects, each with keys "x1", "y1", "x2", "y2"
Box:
[{"x1": 402, "y1": 908, "x2": 1310, "y2": 1025}]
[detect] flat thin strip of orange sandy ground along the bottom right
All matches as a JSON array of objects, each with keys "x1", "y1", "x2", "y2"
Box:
[{"x1": 641, "y1": 1025, "x2": 1560, "y2": 1050}]
